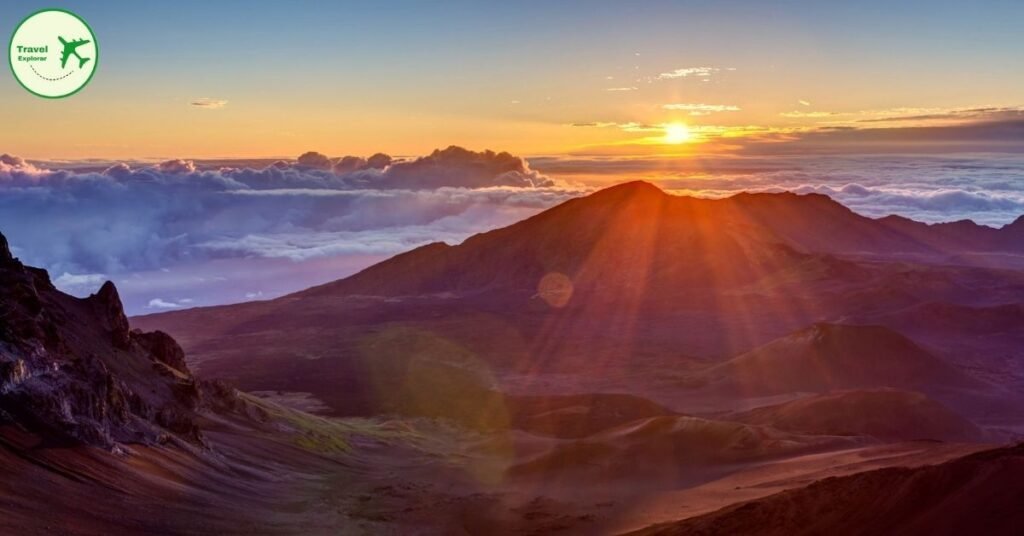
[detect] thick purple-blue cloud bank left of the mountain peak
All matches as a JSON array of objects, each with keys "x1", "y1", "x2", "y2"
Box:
[{"x1": 0, "y1": 147, "x2": 578, "y2": 280}]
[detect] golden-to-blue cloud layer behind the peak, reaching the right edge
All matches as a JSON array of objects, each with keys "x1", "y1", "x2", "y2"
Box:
[{"x1": 530, "y1": 154, "x2": 1024, "y2": 226}]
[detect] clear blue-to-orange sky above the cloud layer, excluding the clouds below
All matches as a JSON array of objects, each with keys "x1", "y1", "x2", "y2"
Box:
[{"x1": 0, "y1": 1, "x2": 1024, "y2": 159}]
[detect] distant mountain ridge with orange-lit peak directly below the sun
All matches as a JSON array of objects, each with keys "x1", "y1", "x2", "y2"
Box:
[{"x1": 296, "y1": 181, "x2": 1024, "y2": 296}]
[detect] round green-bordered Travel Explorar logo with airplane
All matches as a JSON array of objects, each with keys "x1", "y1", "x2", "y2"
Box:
[{"x1": 7, "y1": 9, "x2": 99, "y2": 98}]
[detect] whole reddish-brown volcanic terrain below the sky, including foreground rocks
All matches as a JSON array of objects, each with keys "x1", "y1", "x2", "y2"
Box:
[{"x1": 0, "y1": 182, "x2": 1024, "y2": 534}]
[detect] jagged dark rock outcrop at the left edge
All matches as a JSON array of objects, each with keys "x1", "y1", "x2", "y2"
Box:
[{"x1": 0, "y1": 235, "x2": 212, "y2": 450}]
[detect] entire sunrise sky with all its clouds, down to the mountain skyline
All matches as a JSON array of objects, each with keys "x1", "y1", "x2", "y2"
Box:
[{"x1": 0, "y1": 1, "x2": 1024, "y2": 314}]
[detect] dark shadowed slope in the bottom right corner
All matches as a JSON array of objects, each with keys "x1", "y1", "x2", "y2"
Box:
[{"x1": 634, "y1": 446, "x2": 1024, "y2": 536}]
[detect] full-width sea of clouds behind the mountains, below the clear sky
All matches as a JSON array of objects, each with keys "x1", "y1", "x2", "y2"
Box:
[{"x1": 0, "y1": 147, "x2": 1024, "y2": 314}]
